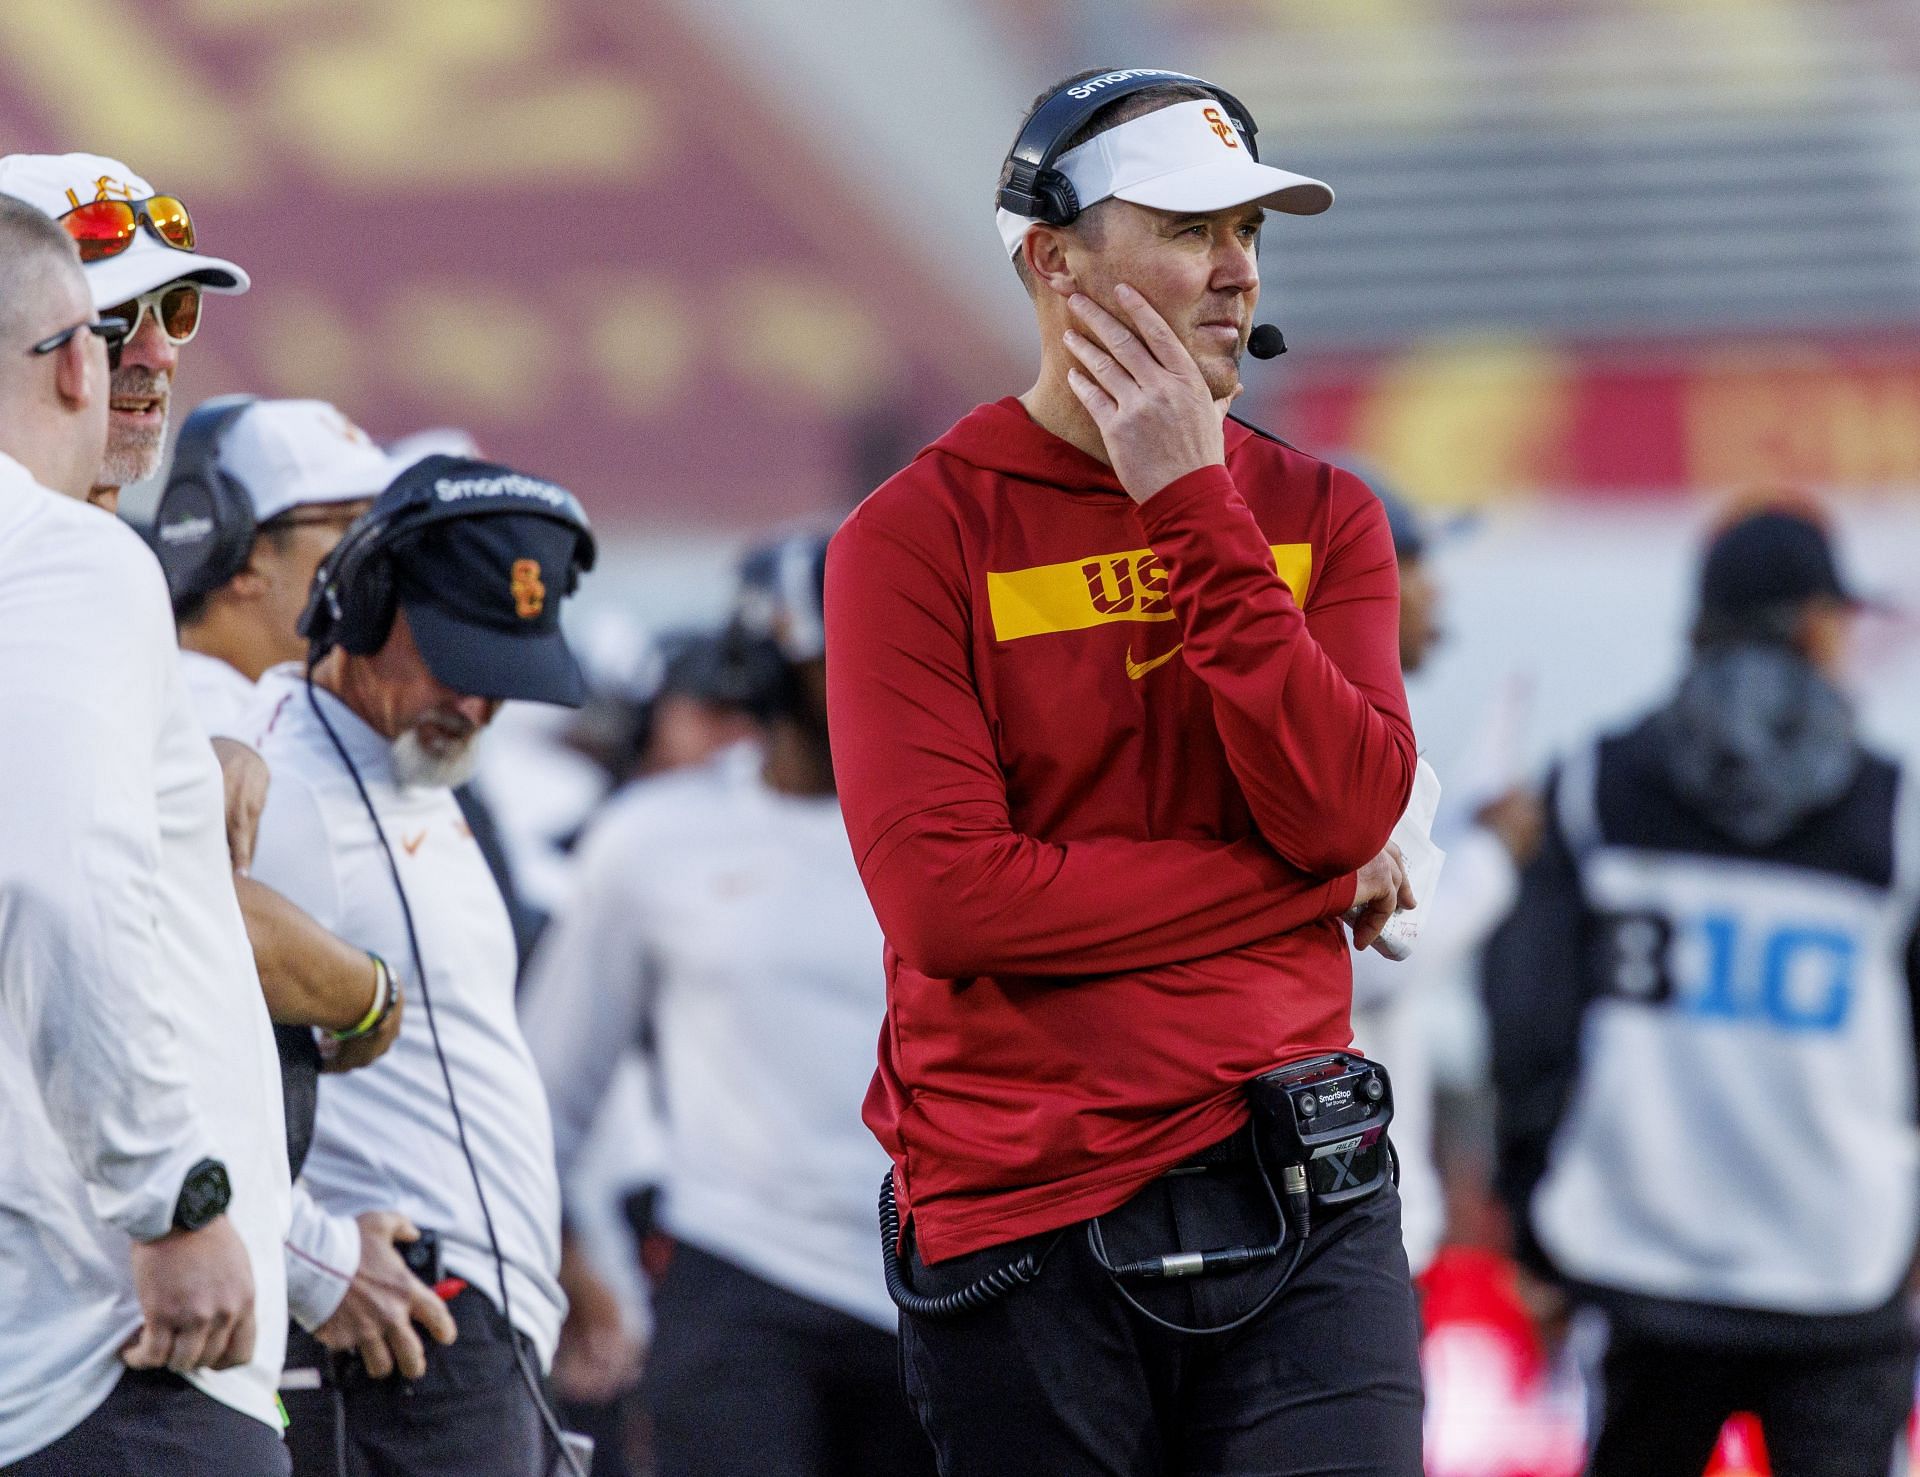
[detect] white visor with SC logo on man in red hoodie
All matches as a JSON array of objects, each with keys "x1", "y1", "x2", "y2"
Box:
[{"x1": 995, "y1": 98, "x2": 1332, "y2": 255}]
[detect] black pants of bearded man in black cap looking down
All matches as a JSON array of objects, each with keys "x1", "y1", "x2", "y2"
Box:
[{"x1": 284, "y1": 1287, "x2": 553, "y2": 1477}]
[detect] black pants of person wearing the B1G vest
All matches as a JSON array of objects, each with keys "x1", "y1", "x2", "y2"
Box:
[{"x1": 1588, "y1": 1337, "x2": 1914, "y2": 1477}]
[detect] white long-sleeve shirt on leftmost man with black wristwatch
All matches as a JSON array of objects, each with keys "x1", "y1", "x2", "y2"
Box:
[{"x1": 0, "y1": 457, "x2": 288, "y2": 1467}]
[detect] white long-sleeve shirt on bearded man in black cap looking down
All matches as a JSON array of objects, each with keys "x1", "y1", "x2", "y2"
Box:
[{"x1": 234, "y1": 666, "x2": 566, "y2": 1364}]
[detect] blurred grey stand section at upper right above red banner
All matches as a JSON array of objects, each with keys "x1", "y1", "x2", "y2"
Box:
[{"x1": 1194, "y1": 0, "x2": 1920, "y2": 346}]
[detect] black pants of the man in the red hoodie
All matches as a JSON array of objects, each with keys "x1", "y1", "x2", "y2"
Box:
[{"x1": 900, "y1": 1162, "x2": 1428, "y2": 1477}]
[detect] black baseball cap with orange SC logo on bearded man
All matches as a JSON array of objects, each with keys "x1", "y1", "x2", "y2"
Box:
[{"x1": 394, "y1": 513, "x2": 588, "y2": 707}]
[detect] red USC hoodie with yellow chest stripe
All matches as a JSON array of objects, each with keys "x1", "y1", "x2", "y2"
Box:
[{"x1": 826, "y1": 400, "x2": 1413, "y2": 1262}]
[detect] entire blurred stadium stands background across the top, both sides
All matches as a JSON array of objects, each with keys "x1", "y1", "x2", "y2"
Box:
[{"x1": 0, "y1": 0, "x2": 1920, "y2": 522}]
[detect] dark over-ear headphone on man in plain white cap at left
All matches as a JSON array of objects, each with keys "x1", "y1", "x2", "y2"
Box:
[{"x1": 146, "y1": 396, "x2": 259, "y2": 615}]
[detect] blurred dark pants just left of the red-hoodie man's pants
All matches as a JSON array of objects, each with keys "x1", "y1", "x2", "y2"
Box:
[{"x1": 645, "y1": 1243, "x2": 933, "y2": 1477}]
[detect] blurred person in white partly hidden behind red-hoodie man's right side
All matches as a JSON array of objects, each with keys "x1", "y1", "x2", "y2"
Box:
[{"x1": 1354, "y1": 469, "x2": 1542, "y2": 1277}]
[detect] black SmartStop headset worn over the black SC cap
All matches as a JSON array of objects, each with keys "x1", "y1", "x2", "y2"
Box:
[{"x1": 300, "y1": 455, "x2": 595, "y2": 665}]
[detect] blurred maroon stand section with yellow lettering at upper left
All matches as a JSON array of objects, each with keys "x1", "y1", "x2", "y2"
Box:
[{"x1": 0, "y1": 0, "x2": 1014, "y2": 528}]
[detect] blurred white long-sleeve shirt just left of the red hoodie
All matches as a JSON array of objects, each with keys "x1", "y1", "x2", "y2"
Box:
[{"x1": 520, "y1": 745, "x2": 895, "y2": 1329}]
